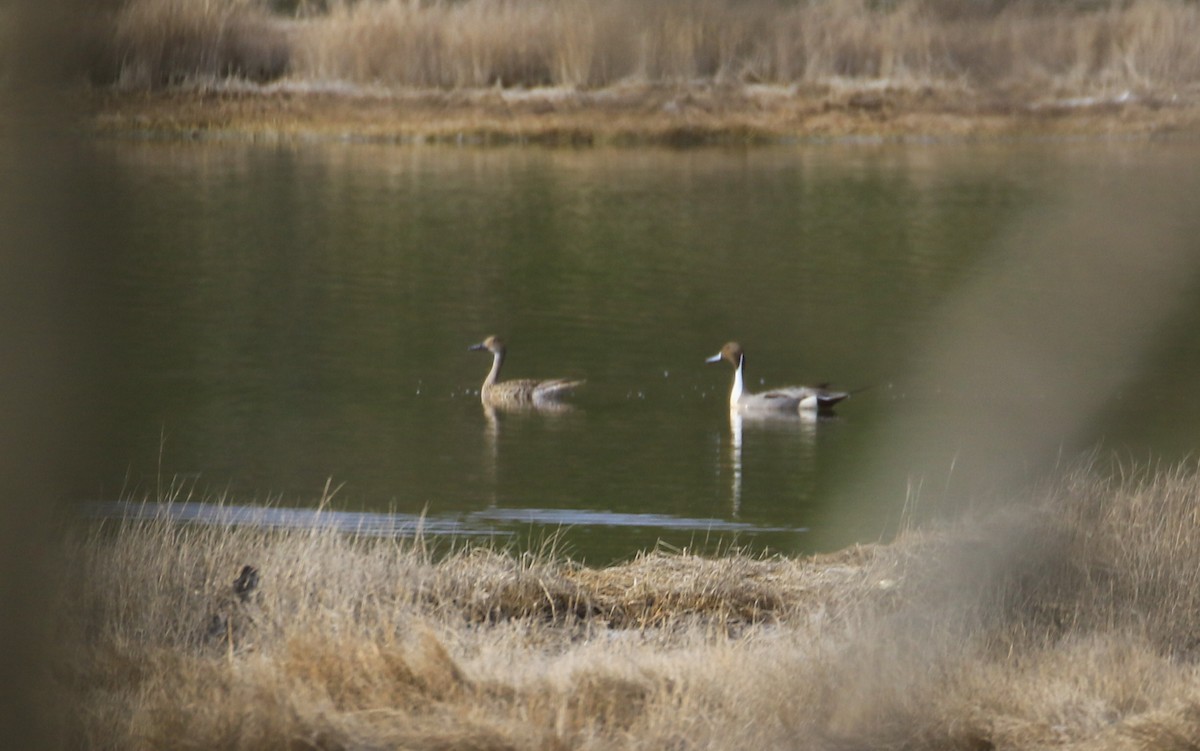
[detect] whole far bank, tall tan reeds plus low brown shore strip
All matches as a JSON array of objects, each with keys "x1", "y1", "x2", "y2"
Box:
[{"x1": 79, "y1": 0, "x2": 1200, "y2": 143}]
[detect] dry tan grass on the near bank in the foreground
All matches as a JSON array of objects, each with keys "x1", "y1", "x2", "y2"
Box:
[{"x1": 56, "y1": 458, "x2": 1200, "y2": 750}]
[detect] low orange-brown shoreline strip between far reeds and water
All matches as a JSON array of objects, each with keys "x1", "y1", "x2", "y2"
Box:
[{"x1": 87, "y1": 82, "x2": 1200, "y2": 148}]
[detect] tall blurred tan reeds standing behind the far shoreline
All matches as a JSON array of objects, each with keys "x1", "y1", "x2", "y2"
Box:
[{"x1": 96, "y1": 0, "x2": 1200, "y2": 94}]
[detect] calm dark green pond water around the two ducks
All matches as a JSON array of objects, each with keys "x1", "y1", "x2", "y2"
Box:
[{"x1": 88, "y1": 136, "x2": 1200, "y2": 563}]
